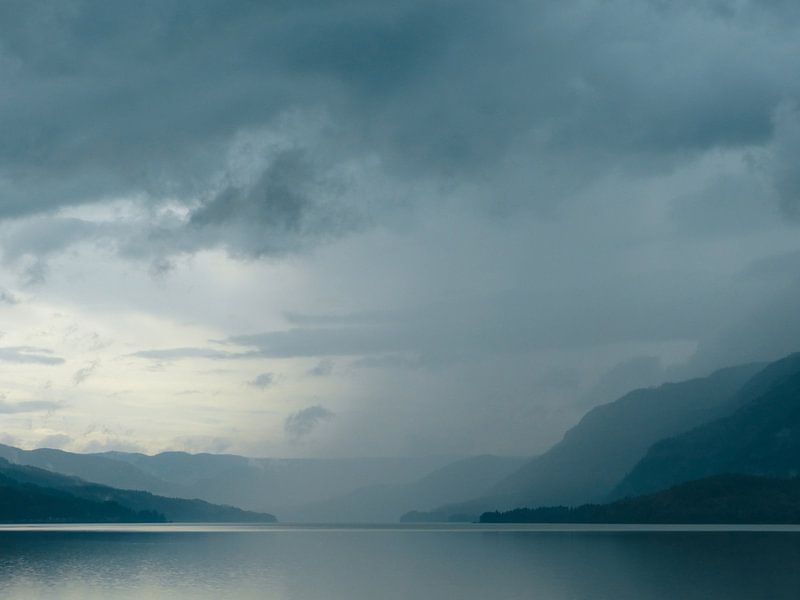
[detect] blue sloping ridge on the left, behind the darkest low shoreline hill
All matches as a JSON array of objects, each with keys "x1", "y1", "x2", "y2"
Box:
[{"x1": 0, "y1": 459, "x2": 275, "y2": 523}]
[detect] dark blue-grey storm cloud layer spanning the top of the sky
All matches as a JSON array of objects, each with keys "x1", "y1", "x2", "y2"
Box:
[{"x1": 0, "y1": 0, "x2": 800, "y2": 256}]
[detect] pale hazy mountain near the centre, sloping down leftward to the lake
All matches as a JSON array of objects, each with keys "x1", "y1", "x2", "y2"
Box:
[{"x1": 280, "y1": 455, "x2": 526, "y2": 523}]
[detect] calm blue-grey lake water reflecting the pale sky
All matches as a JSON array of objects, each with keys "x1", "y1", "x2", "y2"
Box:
[{"x1": 0, "y1": 525, "x2": 800, "y2": 600}]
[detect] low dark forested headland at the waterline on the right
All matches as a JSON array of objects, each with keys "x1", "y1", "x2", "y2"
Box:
[{"x1": 480, "y1": 475, "x2": 800, "y2": 524}]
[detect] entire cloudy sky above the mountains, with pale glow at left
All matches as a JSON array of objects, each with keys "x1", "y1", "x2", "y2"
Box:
[{"x1": 0, "y1": 0, "x2": 800, "y2": 457}]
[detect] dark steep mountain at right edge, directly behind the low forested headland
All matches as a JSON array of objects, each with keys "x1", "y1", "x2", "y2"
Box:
[{"x1": 613, "y1": 354, "x2": 800, "y2": 497}]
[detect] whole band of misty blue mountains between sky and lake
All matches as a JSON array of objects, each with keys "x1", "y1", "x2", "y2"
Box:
[{"x1": 0, "y1": 354, "x2": 800, "y2": 524}]
